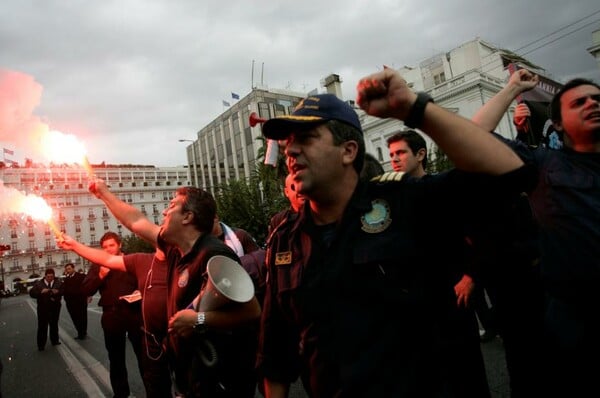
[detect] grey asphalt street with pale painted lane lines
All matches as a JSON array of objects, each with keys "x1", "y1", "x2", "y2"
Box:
[{"x1": 0, "y1": 294, "x2": 510, "y2": 398}]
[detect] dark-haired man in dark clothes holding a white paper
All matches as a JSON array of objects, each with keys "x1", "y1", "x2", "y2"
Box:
[{"x1": 82, "y1": 231, "x2": 144, "y2": 398}]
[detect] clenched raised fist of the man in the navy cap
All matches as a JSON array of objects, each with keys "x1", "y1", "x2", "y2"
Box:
[{"x1": 356, "y1": 67, "x2": 417, "y2": 120}]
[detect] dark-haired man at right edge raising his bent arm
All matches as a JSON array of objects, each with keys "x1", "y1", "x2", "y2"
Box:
[{"x1": 472, "y1": 71, "x2": 600, "y2": 397}]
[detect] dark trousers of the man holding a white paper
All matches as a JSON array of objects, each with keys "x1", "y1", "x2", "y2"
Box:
[{"x1": 101, "y1": 304, "x2": 143, "y2": 398}]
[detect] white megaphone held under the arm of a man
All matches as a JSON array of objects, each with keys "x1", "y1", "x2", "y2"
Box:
[{"x1": 198, "y1": 256, "x2": 254, "y2": 311}]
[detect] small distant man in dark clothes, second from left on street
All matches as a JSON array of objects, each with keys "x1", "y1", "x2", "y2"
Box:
[{"x1": 63, "y1": 263, "x2": 91, "y2": 340}]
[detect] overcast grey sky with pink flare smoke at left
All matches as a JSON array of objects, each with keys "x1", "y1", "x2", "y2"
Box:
[{"x1": 0, "y1": 0, "x2": 600, "y2": 166}]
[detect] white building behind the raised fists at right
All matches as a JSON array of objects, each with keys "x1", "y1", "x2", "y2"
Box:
[{"x1": 357, "y1": 38, "x2": 545, "y2": 171}]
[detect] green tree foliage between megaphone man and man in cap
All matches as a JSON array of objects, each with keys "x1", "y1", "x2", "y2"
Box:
[{"x1": 215, "y1": 137, "x2": 289, "y2": 245}]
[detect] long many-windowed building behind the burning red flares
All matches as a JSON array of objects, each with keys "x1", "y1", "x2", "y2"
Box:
[{"x1": 0, "y1": 165, "x2": 191, "y2": 289}]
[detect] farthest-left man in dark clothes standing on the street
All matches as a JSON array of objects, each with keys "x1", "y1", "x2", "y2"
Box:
[{"x1": 29, "y1": 268, "x2": 63, "y2": 351}]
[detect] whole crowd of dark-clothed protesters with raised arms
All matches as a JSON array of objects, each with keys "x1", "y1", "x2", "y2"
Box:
[{"x1": 12, "y1": 68, "x2": 600, "y2": 398}]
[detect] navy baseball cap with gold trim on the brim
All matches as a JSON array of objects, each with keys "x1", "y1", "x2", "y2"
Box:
[{"x1": 262, "y1": 94, "x2": 362, "y2": 140}]
